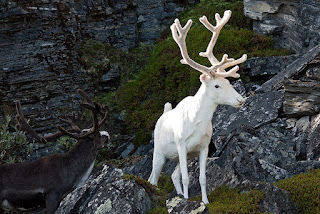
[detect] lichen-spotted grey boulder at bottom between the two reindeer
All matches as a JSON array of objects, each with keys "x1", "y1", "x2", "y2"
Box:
[{"x1": 56, "y1": 165, "x2": 151, "y2": 214}]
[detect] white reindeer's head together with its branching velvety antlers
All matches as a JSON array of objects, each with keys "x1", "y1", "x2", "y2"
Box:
[{"x1": 170, "y1": 10, "x2": 247, "y2": 107}]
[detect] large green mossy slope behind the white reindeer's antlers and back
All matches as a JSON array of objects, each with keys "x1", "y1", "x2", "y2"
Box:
[{"x1": 116, "y1": 0, "x2": 288, "y2": 144}]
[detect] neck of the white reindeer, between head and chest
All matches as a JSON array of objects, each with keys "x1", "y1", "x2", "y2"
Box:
[{"x1": 194, "y1": 83, "x2": 218, "y2": 121}]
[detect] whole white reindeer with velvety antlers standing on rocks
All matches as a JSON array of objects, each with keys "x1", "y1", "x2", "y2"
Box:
[{"x1": 149, "y1": 10, "x2": 247, "y2": 204}]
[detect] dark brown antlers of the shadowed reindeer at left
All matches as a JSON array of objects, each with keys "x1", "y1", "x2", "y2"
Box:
[{"x1": 16, "y1": 89, "x2": 108, "y2": 143}]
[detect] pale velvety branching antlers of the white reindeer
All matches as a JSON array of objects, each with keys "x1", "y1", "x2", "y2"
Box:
[{"x1": 170, "y1": 10, "x2": 247, "y2": 78}]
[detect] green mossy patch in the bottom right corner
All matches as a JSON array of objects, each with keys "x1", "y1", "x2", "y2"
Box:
[{"x1": 275, "y1": 169, "x2": 320, "y2": 214}]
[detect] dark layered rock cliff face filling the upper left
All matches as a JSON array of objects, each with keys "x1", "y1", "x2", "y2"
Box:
[{"x1": 0, "y1": 0, "x2": 197, "y2": 133}]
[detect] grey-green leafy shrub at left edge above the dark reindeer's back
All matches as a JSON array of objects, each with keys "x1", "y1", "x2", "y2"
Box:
[{"x1": 0, "y1": 116, "x2": 33, "y2": 164}]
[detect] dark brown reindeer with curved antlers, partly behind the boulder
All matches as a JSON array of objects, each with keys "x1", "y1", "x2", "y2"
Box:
[{"x1": 0, "y1": 90, "x2": 109, "y2": 214}]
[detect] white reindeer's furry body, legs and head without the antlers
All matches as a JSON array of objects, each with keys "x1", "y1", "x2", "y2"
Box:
[{"x1": 149, "y1": 76, "x2": 244, "y2": 203}]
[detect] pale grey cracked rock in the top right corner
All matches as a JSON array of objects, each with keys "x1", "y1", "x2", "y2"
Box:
[{"x1": 244, "y1": 0, "x2": 320, "y2": 53}]
